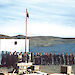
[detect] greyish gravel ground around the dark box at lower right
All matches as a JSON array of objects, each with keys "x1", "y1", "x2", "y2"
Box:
[{"x1": 40, "y1": 65, "x2": 75, "y2": 74}]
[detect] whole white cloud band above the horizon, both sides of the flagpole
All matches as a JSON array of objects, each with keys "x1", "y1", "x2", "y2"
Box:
[{"x1": 0, "y1": 21, "x2": 75, "y2": 37}]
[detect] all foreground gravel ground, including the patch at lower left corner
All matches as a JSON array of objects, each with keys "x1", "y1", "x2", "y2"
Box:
[{"x1": 0, "y1": 65, "x2": 75, "y2": 74}]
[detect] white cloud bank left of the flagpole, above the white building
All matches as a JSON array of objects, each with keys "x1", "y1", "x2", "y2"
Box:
[{"x1": 0, "y1": 21, "x2": 25, "y2": 36}]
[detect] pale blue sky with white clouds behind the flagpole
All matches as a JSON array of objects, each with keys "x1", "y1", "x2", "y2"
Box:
[{"x1": 0, "y1": 0, "x2": 75, "y2": 37}]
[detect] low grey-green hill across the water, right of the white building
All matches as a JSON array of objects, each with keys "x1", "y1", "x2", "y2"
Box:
[{"x1": 30, "y1": 36, "x2": 75, "y2": 46}]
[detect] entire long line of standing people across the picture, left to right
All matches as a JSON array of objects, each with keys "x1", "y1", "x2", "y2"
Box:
[{"x1": 1, "y1": 51, "x2": 75, "y2": 68}]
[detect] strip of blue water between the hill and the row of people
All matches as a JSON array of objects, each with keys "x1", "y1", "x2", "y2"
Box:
[{"x1": 30, "y1": 43, "x2": 75, "y2": 55}]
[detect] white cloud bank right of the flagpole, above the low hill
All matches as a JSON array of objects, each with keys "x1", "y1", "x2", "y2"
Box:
[{"x1": 28, "y1": 23, "x2": 75, "y2": 37}]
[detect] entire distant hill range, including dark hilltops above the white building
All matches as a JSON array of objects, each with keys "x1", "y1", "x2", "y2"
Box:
[{"x1": 0, "y1": 34, "x2": 75, "y2": 46}]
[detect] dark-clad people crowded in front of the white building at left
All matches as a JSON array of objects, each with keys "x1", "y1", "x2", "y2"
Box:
[{"x1": 1, "y1": 51, "x2": 29, "y2": 67}]
